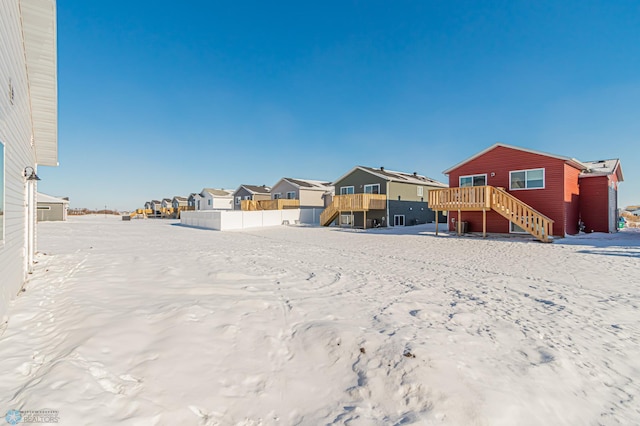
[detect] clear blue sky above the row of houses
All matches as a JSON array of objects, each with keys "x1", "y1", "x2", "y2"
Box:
[{"x1": 38, "y1": 0, "x2": 640, "y2": 210}]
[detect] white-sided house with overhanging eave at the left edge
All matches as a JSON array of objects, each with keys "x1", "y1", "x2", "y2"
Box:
[{"x1": 0, "y1": 0, "x2": 58, "y2": 322}]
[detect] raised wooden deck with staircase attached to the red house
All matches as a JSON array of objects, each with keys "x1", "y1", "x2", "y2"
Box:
[{"x1": 429, "y1": 186, "x2": 553, "y2": 242}]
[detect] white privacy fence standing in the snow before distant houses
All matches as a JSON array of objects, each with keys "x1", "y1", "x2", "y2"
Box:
[{"x1": 180, "y1": 209, "x2": 321, "y2": 231}]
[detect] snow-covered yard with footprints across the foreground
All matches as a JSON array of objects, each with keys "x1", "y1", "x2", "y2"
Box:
[{"x1": 0, "y1": 216, "x2": 640, "y2": 425}]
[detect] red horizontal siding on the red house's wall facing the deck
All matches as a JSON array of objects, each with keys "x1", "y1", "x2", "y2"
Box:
[{"x1": 449, "y1": 146, "x2": 578, "y2": 236}]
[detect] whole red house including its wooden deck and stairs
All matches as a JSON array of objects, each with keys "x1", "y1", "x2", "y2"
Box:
[{"x1": 430, "y1": 143, "x2": 622, "y2": 241}]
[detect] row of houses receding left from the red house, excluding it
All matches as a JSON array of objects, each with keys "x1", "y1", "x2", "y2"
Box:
[{"x1": 139, "y1": 166, "x2": 447, "y2": 228}]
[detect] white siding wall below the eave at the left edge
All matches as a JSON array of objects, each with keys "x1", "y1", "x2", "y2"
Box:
[{"x1": 0, "y1": 0, "x2": 35, "y2": 320}]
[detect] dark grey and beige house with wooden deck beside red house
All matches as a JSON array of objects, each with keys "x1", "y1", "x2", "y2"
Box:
[{"x1": 320, "y1": 166, "x2": 447, "y2": 228}]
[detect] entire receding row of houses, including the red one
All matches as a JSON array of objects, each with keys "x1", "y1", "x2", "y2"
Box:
[{"x1": 136, "y1": 143, "x2": 623, "y2": 241}]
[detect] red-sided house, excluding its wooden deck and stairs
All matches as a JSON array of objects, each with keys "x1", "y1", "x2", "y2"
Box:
[{"x1": 444, "y1": 143, "x2": 623, "y2": 236}]
